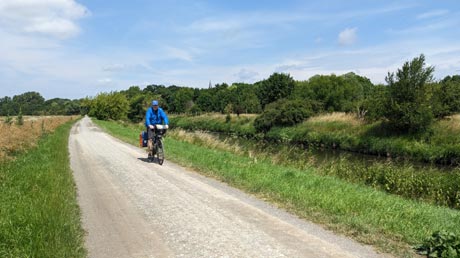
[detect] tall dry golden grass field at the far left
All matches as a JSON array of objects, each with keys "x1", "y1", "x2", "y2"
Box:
[{"x1": 0, "y1": 116, "x2": 78, "y2": 161}]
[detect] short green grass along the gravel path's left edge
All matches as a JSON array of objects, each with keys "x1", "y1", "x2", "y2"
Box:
[{"x1": 0, "y1": 122, "x2": 86, "y2": 257}]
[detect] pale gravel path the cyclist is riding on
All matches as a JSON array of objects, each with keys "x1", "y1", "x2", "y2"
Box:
[{"x1": 69, "y1": 117, "x2": 390, "y2": 258}]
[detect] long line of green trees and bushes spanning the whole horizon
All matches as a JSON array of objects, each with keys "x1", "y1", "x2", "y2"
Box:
[{"x1": 0, "y1": 55, "x2": 460, "y2": 133}]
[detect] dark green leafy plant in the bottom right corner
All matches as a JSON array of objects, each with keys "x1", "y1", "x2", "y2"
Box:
[{"x1": 416, "y1": 231, "x2": 460, "y2": 258}]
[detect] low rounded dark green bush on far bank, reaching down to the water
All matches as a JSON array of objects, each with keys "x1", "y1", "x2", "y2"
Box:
[{"x1": 254, "y1": 99, "x2": 313, "y2": 132}]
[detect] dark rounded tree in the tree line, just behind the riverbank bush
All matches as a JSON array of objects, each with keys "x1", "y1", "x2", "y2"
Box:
[{"x1": 257, "y1": 73, "x2": 295, "y2": 108}]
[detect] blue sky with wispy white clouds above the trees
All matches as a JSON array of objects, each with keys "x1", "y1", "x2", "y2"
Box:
[{"x1": 0, "y1": 0, "x2": 460, "y2": 99}]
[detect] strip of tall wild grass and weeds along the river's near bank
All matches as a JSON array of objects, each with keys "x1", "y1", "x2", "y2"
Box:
[{"x1": 170, "y1": 129, "x2": 460, "y2": 210}]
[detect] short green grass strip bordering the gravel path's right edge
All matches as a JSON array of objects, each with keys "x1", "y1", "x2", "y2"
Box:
[{"x1": 94, "y1": 118, "x2": 460, "y2": 256}]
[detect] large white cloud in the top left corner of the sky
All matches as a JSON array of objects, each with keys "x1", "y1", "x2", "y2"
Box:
[{"x1": 0, "y1": 0, "x2": 89, "y2": 39}]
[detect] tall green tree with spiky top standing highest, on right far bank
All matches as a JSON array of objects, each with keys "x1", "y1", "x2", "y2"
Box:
[{"x1": 385, "y1": 54, "x2": 434, "y2": 133}]
